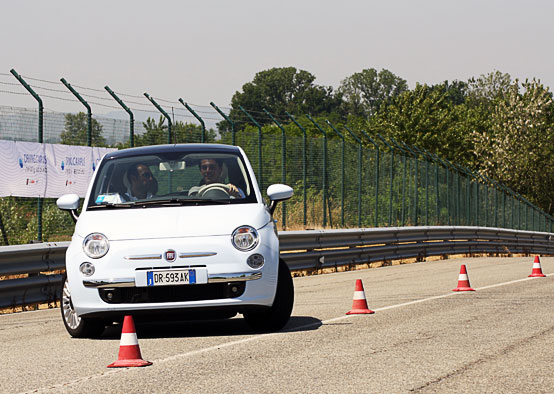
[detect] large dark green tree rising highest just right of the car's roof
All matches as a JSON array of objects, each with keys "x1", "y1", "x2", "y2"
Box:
[{"x1": 224, "y1": 67, "x2": 341, "y2": 131}]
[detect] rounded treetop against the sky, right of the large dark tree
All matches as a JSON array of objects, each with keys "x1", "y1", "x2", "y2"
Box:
[{"x1": 339, "y1": 68, "x2": 408, "y2": 118}]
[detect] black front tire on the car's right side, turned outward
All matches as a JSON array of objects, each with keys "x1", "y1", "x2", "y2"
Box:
[{"x1": 244, "y1": 259, "x2": 294, "y2": 332}]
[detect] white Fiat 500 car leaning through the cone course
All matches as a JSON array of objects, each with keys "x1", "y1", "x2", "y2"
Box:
[{"x1": 57, "y1": 144, "x2": 294, "y2": 337}]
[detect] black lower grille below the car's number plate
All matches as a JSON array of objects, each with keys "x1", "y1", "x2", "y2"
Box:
[{"x1": 98, "y1": 282, "x2": 245, "y2": 304}]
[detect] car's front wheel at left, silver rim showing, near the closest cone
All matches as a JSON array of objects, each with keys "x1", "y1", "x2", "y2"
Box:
[{"x1": 60, "y1": 275, "x2": 106, "y2": 338}]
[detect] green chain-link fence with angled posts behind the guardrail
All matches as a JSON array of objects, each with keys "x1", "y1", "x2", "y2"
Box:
[{"x1": 0, "y1": 96, "x2": 553, "y2": 245}]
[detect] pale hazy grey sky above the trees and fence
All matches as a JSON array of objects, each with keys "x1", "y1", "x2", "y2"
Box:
[{"x1": 0, "y1": 0, "x2": 554, "y2": 114}]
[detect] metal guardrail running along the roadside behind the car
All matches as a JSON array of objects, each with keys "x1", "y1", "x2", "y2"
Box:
[{"x1": 0, "y1": 226, "x2": 554, "y2": 308}]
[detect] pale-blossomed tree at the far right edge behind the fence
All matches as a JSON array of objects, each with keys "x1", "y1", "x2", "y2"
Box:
[{"x1": 473, "y1": 79, "x2": 554, "y2": 212}]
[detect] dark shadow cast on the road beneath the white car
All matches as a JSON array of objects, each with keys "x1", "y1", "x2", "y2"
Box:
[{"x1": 99, "y1": 316, "x2": 322, "y2": 339}]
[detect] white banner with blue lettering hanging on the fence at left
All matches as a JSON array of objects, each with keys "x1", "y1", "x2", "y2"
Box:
[{"x1": 0, "y1": 140, "x2": 116, "y2": 198}]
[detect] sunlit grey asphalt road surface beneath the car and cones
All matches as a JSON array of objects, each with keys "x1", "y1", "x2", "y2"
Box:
[{"x1": 0, "y1": 257, "x2": 554, "y2": 393}]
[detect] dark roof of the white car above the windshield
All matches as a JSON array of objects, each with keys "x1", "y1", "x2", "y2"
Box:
[{"x1": 104, "y1": 144, "x2": 240, "y2": 159}]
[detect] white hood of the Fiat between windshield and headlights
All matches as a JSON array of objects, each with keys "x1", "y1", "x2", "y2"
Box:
[{"x1": 75, "y1": 204, "x2": 271, "y2": 241}]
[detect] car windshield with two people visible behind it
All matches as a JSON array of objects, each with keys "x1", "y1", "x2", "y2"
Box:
[{"x1": 88, "y1": 151, "x2": 256, "y2": 209}]
